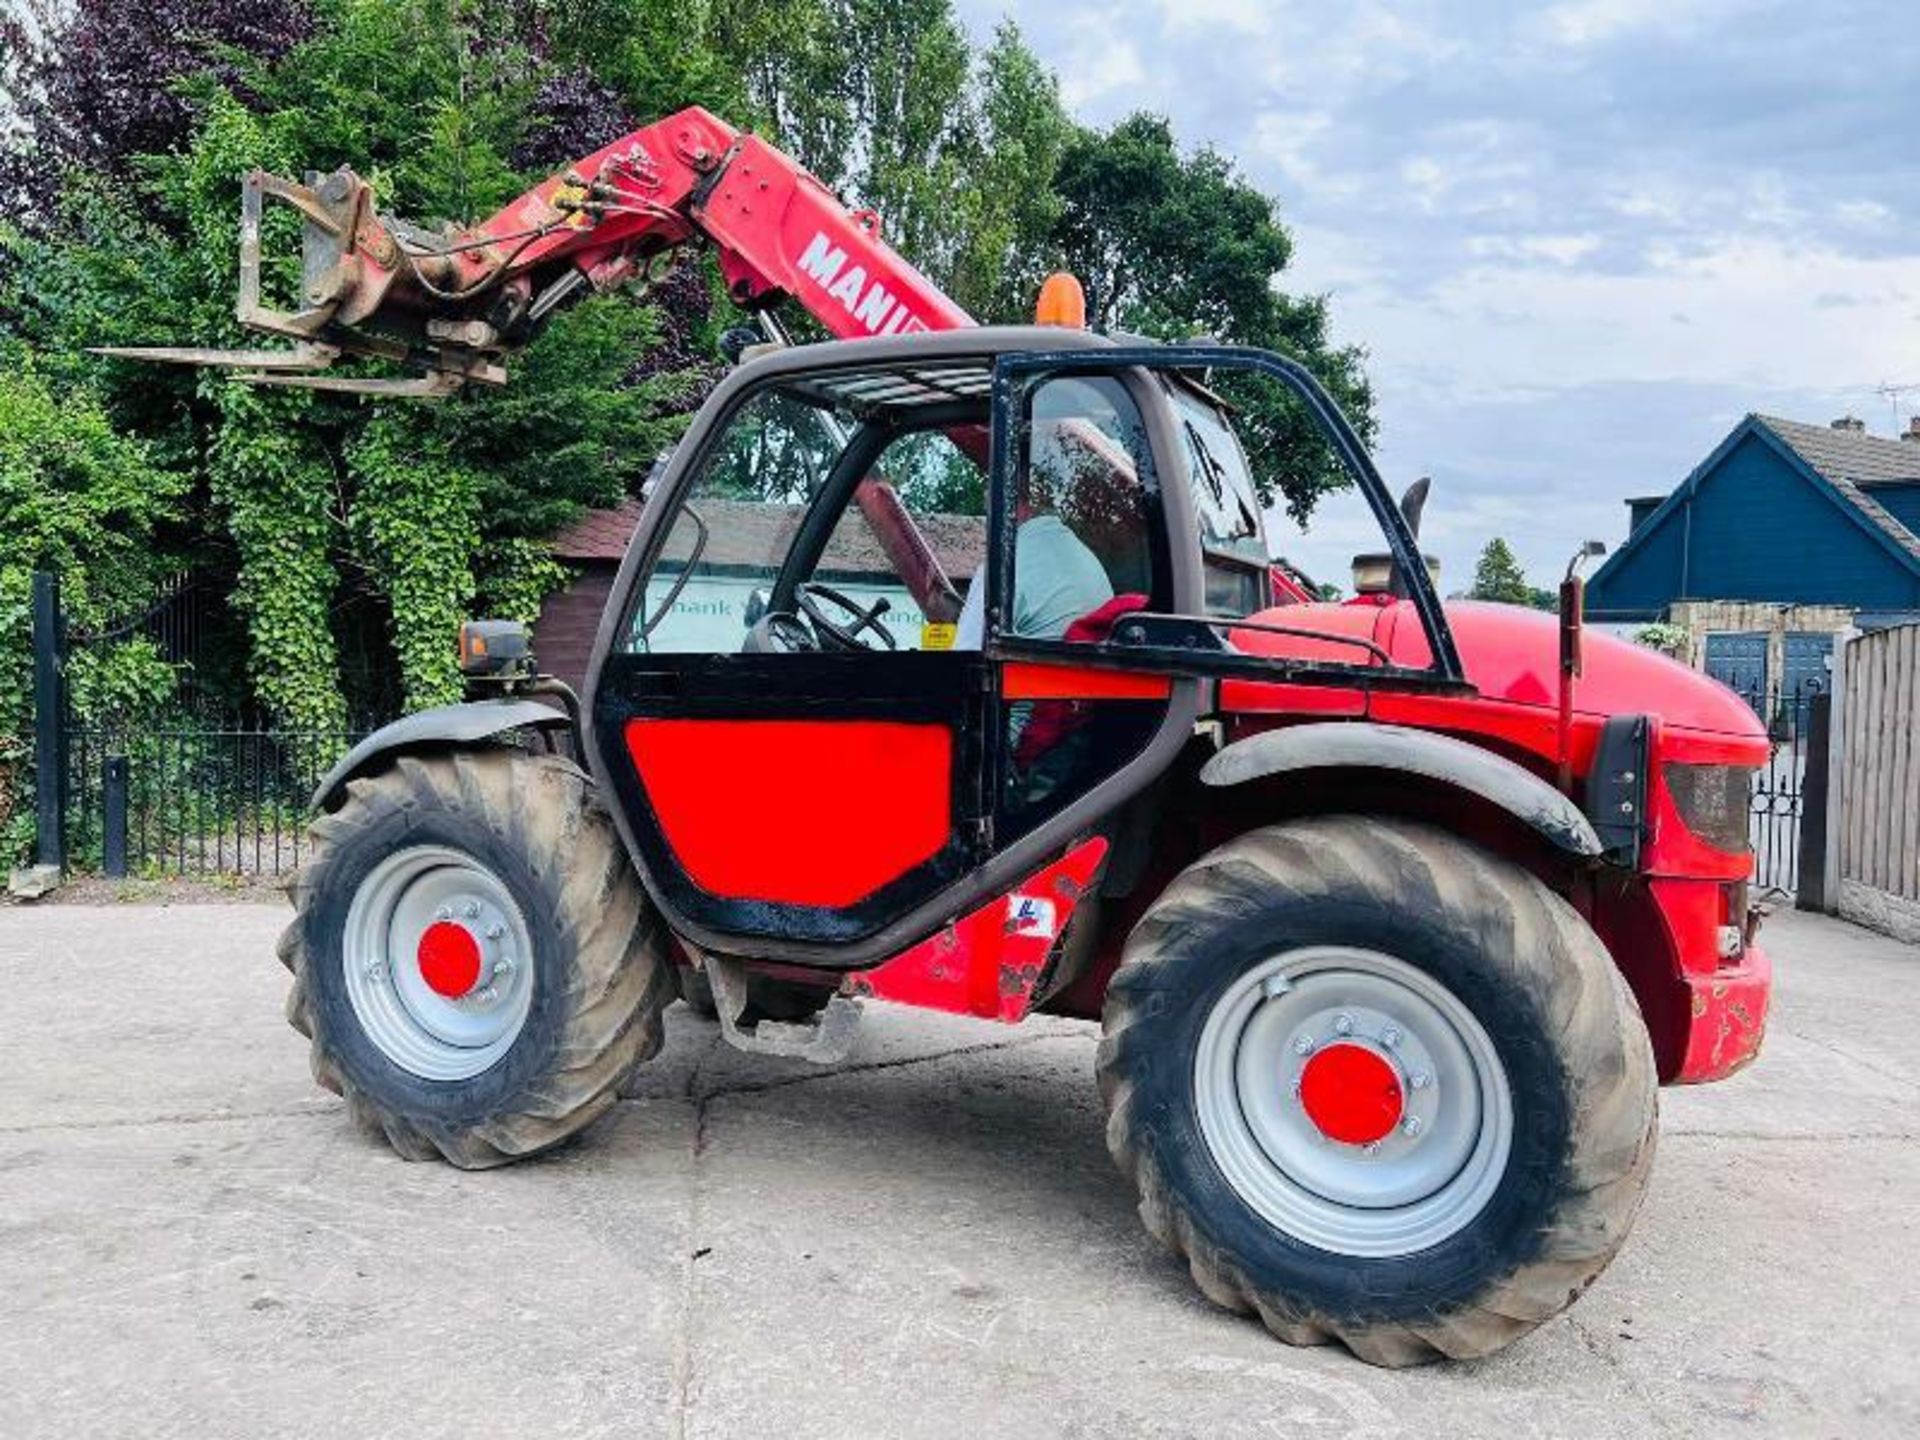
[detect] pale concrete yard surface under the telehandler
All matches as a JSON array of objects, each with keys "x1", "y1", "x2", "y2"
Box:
[{"x1": 0, "y1": 904, "x2": 1920, "y2": 1440}]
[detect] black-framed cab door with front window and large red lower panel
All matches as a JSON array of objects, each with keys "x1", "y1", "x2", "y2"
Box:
[{"x1": 591, "y1": 386, "x2": 987, "y2": 950}]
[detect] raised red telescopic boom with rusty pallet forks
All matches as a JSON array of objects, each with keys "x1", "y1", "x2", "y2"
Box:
[{"x1": 102, "y1": 108, "x2": 973, "y2": 396}]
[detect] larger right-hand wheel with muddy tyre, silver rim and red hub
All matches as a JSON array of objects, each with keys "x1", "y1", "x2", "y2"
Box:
[{"x1": 1098, "y1": 816, "x2": 1657, "y2": 1365}]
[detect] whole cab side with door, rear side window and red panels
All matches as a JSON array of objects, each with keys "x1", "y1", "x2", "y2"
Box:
[{"x1": 589, "y1": 359, "x2": 1196, "y2": 966}]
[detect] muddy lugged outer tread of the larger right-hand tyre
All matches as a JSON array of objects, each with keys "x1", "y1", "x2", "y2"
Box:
[{"x1": 1096, "y1": 816, "x2": 1657, "y2": 1367}]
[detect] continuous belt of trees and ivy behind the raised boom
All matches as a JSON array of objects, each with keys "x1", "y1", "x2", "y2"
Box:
[{"x1": 0, "y1": 0, "x2": 1371, "y2": 858}]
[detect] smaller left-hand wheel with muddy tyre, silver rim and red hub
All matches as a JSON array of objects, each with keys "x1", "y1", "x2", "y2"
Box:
[{"x1": 280, "y1": 747, "x2": 674, "y2": 1169}]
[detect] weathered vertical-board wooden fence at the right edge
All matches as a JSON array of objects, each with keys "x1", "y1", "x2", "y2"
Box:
[{"x1": 1830, "y1": 624, "x2": 1920, "y2": 941}]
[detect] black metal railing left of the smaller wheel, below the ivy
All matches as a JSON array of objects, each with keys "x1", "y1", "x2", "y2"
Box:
[{"x1": 65, "y1": 718, "x2": 367, "y2": 877}]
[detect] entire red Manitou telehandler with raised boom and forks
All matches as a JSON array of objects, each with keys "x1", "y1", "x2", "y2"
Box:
[{"x1": 112, "y1": 109, "x2": 1770, "y2": 1365}]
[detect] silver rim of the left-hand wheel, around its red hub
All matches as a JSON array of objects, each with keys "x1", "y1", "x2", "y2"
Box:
[{"x1": 340, "y1": 845, "x2": 534, "y2": 1081}]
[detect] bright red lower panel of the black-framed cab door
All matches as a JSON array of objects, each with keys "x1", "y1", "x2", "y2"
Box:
[{"x1": 626, "y1": 718, "x2": 954, "y2": 906}]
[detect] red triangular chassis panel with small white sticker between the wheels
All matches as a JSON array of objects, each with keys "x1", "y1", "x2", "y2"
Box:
[{"x1": 841, "y1": 837, "x2": 1106, "y2": 1025}]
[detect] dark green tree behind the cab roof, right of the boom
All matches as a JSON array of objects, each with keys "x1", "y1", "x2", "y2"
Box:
[{"x1": 1054, "y1": 115, "x2": 1373, "y2": 520}]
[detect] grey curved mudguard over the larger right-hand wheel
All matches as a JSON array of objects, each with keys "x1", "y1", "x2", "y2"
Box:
[{"x1": 1200, "y1": 720, "x2": 1603, "y2": 858}]
